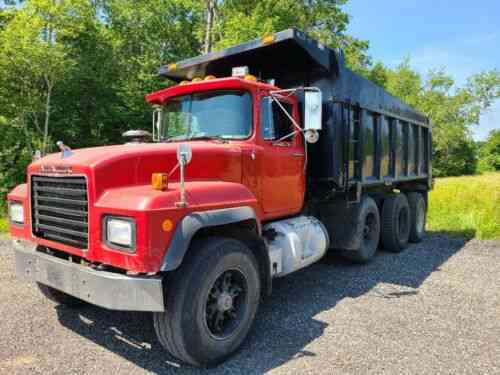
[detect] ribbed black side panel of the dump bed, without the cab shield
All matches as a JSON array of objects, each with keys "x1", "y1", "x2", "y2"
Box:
[{"x1": 308, "y1": 62, "x2": 432, "y2": 191}]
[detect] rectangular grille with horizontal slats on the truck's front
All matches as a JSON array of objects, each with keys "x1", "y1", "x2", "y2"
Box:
[{"x1": 31, "y1": 176, "x2": 88, "y2": 249}]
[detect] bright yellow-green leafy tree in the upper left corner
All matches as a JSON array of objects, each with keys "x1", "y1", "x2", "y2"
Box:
[{"x1": 0, "y1": 0, "x2": 95, "y2": 152}]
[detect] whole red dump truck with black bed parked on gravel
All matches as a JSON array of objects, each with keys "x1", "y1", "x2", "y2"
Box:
[{"x1": 8, "y1": 29, "x2": 432, "y2": 366}]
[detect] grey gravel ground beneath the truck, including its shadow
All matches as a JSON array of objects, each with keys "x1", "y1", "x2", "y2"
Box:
[{"x1": 0, "y1": 234, "x2": 500, "y2": 375}]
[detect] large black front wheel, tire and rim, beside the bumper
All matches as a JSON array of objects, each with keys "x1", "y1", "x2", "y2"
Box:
[{"x1": 153, "y1": 237, "x2": 261, "y2": 366}]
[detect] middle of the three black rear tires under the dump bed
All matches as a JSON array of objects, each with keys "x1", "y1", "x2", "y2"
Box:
[{"x1": 381, "y1": 194, "x2": 410, "y2": 253}]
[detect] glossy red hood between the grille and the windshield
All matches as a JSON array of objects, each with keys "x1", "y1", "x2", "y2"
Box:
[{"x1": 28, "y1": 141, "x2": 242, "y2": 199}]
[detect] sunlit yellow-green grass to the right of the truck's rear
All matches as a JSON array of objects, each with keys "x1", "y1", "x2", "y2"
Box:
[{"x1": 427, "y1": 172, "x2": 500, "y2": 239}]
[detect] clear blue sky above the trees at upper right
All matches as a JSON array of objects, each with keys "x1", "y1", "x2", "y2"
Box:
[{"x1": 344, "y1": 0, "x2": 500, "y2": 140}]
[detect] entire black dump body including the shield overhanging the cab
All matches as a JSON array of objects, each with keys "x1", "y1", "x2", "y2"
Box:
[{"x1": 160, "y1": 29, "x2": 432, "y2": 192}]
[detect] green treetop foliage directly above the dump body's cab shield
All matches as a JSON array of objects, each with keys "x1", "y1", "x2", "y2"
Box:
[{"x1": 203, "y1": 0, "x2": 370, "y2": 71}]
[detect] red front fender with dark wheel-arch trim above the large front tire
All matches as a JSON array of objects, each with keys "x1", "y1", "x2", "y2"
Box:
[{"x1": 94, "y1": 181, "x2": 260, "y2": 272}]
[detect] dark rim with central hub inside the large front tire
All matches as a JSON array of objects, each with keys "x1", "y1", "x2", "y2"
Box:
[{"x1": 205, "y1": 269, "x2": 248, "y2": 340}]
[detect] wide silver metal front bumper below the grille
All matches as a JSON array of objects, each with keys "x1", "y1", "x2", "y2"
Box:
[{"x1": 14, "y1": 240, "x2": 164, "y2": 312}]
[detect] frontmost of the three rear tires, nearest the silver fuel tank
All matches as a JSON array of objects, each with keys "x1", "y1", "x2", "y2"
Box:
[{"x1": 341, "y1": 196, "x2": 380, "y2": 263}]
